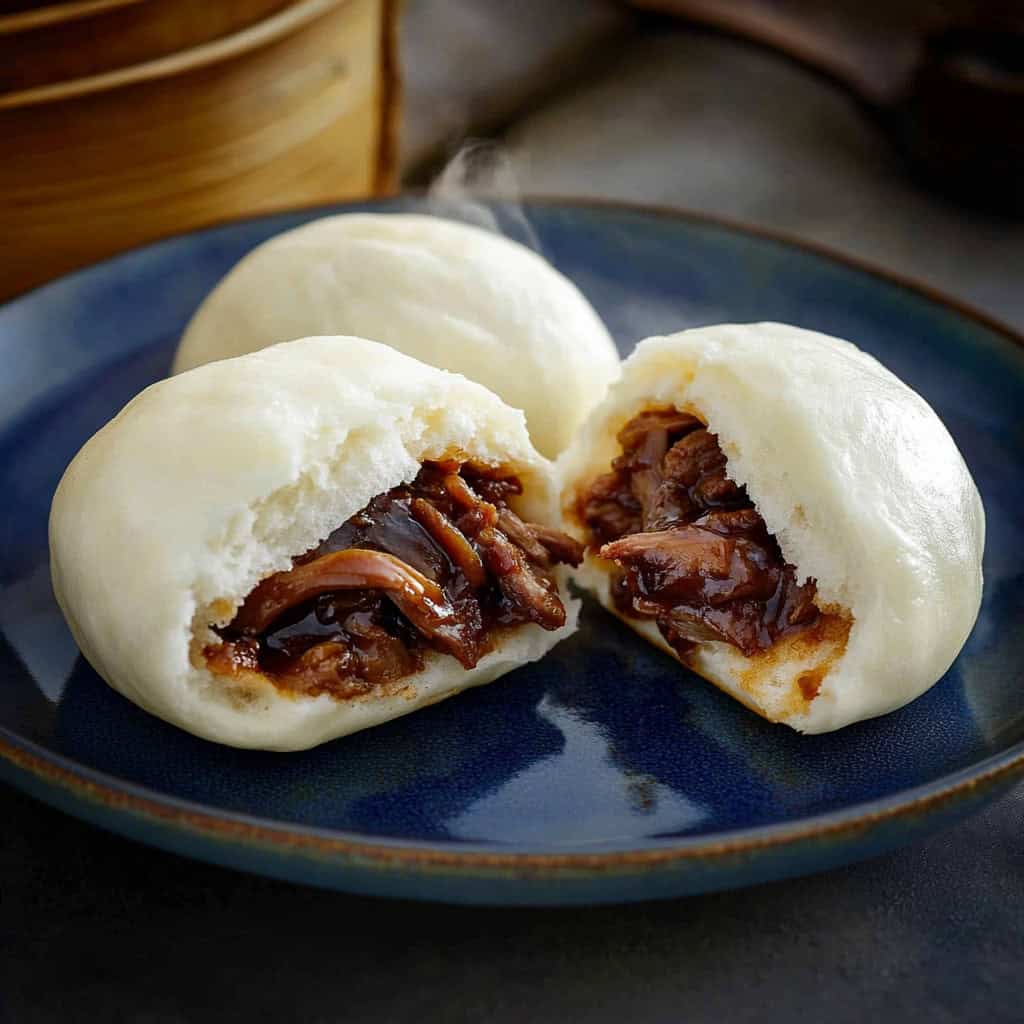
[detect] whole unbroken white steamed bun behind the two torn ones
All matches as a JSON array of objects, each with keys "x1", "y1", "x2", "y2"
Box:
[{"x1": 174, "y1": 213, "x2": 620, "y2": 458}]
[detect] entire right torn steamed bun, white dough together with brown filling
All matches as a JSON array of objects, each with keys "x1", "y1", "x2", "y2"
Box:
[{"x1": 559, "y1": 324, "x2": 984, "y2": 732}]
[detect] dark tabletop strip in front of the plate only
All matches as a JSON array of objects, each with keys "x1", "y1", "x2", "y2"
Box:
[{"x1": 0, "y1": 786, "x2": 1024, "y2": 1024}]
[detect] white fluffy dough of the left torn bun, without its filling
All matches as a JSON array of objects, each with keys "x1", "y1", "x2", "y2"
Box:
[{"x1": 50, "y1": 338, "x2": 578, "y2": 751}]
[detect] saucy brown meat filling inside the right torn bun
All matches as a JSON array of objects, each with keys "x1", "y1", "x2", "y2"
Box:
[{"x1": 578, "y1": 409, "x2": 819, "y2": 656}]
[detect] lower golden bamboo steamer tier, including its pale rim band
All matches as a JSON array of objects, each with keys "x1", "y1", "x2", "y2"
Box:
[{"x1": 0, "y1": 0, "x2": 398, "y2": 298}]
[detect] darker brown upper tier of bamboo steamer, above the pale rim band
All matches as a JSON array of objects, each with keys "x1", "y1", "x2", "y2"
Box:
[{"x1": 0, "y1": 0, "x2": 296, "y2": 92}]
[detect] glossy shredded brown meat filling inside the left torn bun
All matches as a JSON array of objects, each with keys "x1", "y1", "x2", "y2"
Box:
[{"x1": 204, "y1": 461, "x2": 583, "y2": 699}]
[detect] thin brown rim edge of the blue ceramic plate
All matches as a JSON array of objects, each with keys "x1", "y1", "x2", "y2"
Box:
[{"x1": 0, "y1": 190, "x2": 1024, "y2": 871}]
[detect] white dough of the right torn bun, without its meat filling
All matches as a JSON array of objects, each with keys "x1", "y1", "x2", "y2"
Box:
[{"x1": 559, "y1": 324, "x2": 985, "y2": 732}]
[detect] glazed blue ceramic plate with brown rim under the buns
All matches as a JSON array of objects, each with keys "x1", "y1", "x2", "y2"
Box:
[{"x1": 0, "y1": 199, "x2": 1024, "y2": 903}]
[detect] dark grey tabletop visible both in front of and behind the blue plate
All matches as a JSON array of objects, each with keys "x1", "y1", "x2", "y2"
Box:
[{"x1": 8, "y1": 9, "x2": 1024, "y2": 1024}]
